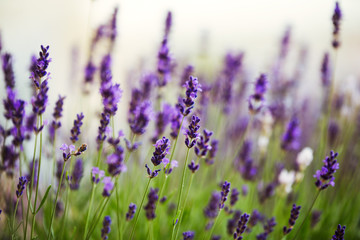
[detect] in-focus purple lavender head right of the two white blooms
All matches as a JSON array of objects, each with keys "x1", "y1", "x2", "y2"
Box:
[{"x1": 314, "y1": 151, "x2": 339, "y2": 190}]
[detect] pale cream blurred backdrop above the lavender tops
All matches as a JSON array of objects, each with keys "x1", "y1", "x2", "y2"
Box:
[{"x1": 0, "y1": 0, "x2": 360, "y2": 123}]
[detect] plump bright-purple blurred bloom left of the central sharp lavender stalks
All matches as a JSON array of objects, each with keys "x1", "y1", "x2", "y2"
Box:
[{"x1": 129, "y1": 101, "x2": 152, "y2": 135}]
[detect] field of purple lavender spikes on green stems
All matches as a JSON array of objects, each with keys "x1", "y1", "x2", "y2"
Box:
[{"x1": 0, "y1": 2, "x2": 360, "y2": 240}]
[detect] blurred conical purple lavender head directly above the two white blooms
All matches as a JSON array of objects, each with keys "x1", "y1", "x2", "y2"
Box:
[{"x1": 281, "y1": 116, "x2": 301, "y2": 151}]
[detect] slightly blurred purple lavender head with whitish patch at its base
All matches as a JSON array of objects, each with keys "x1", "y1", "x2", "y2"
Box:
[{"x1": 248, "y1": 74, "x2": 268, "y2": 113}]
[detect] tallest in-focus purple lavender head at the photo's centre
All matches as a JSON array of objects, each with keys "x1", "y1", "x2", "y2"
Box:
[{"x1": 177, "y1": 76, "x2": 201, "y2": 116}]
